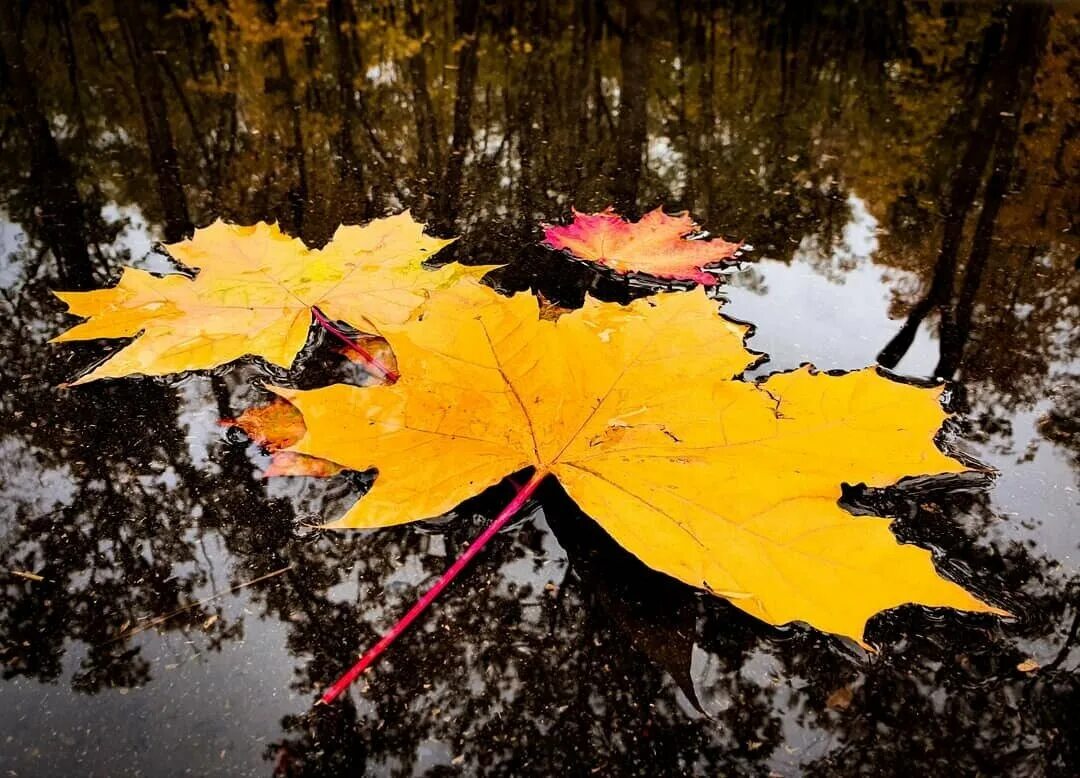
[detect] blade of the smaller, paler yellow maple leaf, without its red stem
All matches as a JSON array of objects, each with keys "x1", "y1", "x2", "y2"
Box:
[{"x1": 54, "y1": 211, "x2": 489, "y2": 384}]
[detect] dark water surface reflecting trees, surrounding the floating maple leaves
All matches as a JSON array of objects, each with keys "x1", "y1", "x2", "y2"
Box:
[{"x1": 0, "y1": 0, "x2": 1080, "y2": 776}]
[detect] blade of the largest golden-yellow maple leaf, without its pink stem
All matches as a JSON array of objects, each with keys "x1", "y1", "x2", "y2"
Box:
[{"x1": 267, "y1": 282, "x2": 1003, "y2": 641}]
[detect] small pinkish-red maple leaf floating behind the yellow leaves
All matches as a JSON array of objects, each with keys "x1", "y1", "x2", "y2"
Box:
[{"x1": 543, "y1": 207, "x2": 740, "y2": 286}]
